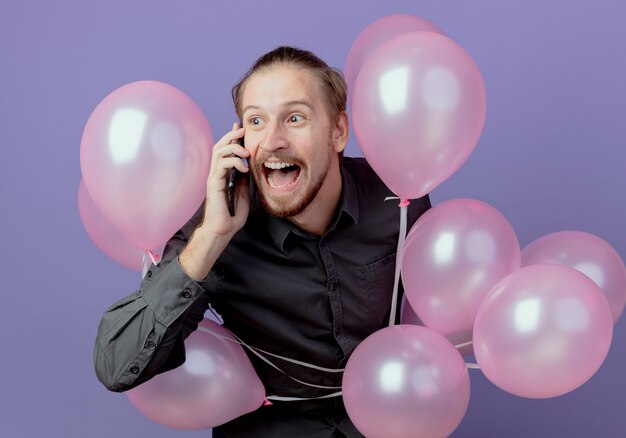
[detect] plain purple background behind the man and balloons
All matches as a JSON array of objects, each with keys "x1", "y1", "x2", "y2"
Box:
[{"x1": 0, "y1": 0, "x2": 626, "y2": 438}]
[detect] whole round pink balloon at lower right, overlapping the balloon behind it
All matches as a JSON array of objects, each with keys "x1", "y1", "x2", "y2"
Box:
[{"x1": 474, "y1": 265, "x2": 613, "y2": 398}]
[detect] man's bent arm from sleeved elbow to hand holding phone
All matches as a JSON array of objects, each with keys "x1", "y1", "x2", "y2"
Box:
[{"x1": 94, "y1": 124, "x2": 249, "y2": 391}]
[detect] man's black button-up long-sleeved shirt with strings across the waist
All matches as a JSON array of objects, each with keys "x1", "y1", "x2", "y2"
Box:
[{"x1": 95, "y1": 158, "x2": 430, "y2": 437}]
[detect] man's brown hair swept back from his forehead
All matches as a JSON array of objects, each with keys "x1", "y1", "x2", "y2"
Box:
[{"x1": 231, "y1": 46, "x2": 348, "y2": 121}]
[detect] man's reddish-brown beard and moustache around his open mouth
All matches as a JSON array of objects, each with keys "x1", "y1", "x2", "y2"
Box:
[{"x1": 252, "y1": 142, "x2": 332, "y2": 218}]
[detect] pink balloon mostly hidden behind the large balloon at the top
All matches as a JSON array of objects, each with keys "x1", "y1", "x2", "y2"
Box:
[{"x1": 344, "y1": 14, "x2": 443, "y2": 101}]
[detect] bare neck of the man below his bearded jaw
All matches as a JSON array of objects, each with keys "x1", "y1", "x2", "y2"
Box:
[{"x1": 288, "y1": 158, "x2": 342, "y2": 236}]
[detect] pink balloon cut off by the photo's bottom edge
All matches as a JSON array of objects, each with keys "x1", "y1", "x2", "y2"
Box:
[{"x1": 342, "y1": 325, "x2": 470, "y2": 438}]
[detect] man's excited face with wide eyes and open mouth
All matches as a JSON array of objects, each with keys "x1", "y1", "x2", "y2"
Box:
[{"x1": 241, "y1": 65, "x2": 338, "y2": 217}]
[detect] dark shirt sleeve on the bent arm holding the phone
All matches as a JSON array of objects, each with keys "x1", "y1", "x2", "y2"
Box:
[{"x1": 94, "y1": 209, "x2": 211, "y2": 392}]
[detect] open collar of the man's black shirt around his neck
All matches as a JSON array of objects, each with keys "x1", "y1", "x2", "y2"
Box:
[{"x1": 251, "y1": 162, "x2": 359, "y2": 248}]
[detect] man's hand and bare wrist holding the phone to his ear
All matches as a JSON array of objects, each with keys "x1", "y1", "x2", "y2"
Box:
[{"x1": 179, "y1": 123, "x2": 250, "y2": 281}]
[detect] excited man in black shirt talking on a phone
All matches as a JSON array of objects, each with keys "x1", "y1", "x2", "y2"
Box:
[{"x1": 94, "y1": 47, "x2": 430, "y2": 438}]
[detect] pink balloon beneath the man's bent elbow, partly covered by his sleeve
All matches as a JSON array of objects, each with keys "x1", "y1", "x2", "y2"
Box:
[{"x1": 126, "y1": 319, "x2": 265, "y2": 430}]
